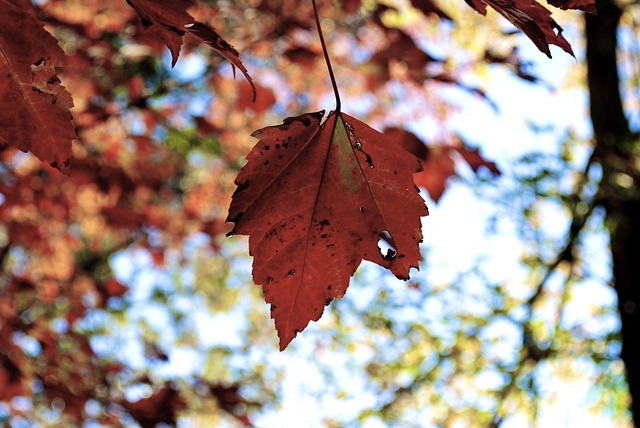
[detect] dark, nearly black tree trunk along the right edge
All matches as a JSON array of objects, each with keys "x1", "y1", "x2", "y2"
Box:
[{"x1": 586, "y1": 0, "x2": 640, "y2": 427}]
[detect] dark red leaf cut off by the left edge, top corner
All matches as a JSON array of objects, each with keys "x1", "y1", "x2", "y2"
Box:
[{"x1": 0, "y1": 0, "x2": 76, "y2": 171}]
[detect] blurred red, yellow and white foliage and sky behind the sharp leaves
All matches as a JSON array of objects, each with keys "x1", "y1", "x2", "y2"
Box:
[{"x1": 0, "y1": 0, "x2": 639, "y2": 427}]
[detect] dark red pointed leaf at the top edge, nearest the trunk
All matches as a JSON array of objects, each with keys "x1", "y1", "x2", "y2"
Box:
[{"x1": 465, "y1": 0, "x2": 594, "y2": 58}]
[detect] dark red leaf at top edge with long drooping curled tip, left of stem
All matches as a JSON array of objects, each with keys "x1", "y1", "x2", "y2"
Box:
[{"x1": 127, "y1": 0, "x2": 256, "y2": 98}]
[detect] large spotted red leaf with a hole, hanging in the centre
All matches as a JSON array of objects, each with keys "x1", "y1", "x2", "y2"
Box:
[{"x1": 228, "y1": 111, "x2": 428, "y2": 350}]
